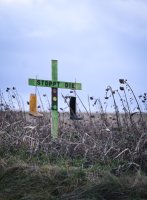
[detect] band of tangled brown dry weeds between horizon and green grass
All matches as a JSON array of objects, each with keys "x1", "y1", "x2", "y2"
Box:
[{"x1": 0, "y1": 111, "x2": 147, "y2": 170}]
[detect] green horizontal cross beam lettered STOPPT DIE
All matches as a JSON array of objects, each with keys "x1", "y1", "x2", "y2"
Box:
[{"x1": 29, "y1": 79, "x2": 82, "y2": 90}]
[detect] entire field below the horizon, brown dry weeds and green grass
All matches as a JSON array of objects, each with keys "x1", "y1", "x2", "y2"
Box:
[{"x1": 0, "y1": 110, "x2": 147, "y2": 200}]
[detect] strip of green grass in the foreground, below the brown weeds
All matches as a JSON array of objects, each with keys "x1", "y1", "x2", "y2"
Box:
[{"x1": 0, "y1": 157, "x2": 147, "y2": 200}]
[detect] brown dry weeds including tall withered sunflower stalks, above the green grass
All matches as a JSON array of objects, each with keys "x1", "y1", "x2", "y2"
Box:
[{"x1": 0, "y1": 79, "x2": 146, "y2": 167}]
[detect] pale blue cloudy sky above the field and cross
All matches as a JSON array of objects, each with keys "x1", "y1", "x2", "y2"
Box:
[{"x1": 0, "y1": 0, "x2": 147, "y2": 111}]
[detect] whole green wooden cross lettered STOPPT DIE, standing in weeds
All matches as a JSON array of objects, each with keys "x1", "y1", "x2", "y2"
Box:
[{"x1": 29, "y1": 60, "x2": 82, "y2": 139}]
